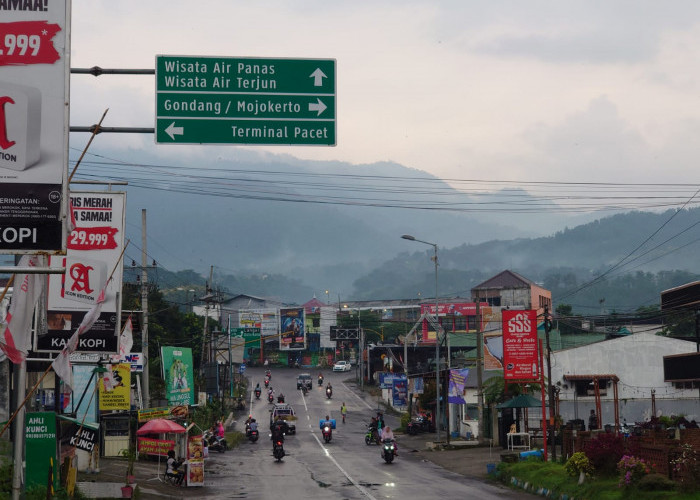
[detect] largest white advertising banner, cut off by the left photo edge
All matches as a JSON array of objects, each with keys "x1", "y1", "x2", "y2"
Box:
[{"x1": 0, "y1": 0, "x2": 70, "y2": 253}]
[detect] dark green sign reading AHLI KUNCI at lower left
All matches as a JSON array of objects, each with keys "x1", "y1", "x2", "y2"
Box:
[{"x1": 24, "y1": 411, "x2": 60, "y2": 490}]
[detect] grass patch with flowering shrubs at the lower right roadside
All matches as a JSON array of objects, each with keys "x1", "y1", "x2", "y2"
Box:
[{"x1": 498, "y1": 460, "x2": 700, "y2": 500}]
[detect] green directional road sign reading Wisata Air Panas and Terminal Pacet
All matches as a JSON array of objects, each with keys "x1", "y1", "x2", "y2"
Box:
[{"x1": 155, "y1": 55, "x2": 336, "y2": 146}]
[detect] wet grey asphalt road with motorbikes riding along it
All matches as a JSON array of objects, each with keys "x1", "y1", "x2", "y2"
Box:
[{"x1": 200, "y1": 369, "x2": 528, "y2": 500}]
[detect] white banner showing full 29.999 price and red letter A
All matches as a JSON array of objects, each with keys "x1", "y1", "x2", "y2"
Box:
[{"x1": 37, "y1": 191, "x2": 126, "y2": 354}]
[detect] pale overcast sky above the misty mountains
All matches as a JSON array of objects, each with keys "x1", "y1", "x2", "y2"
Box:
[{"x1": 71, "y1": 0, "x2": 700, "y2": 188}]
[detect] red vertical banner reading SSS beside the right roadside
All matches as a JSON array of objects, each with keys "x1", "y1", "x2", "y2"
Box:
[{"x1": 501, "y1": 310, "x2": 538, "y2": 380}]
